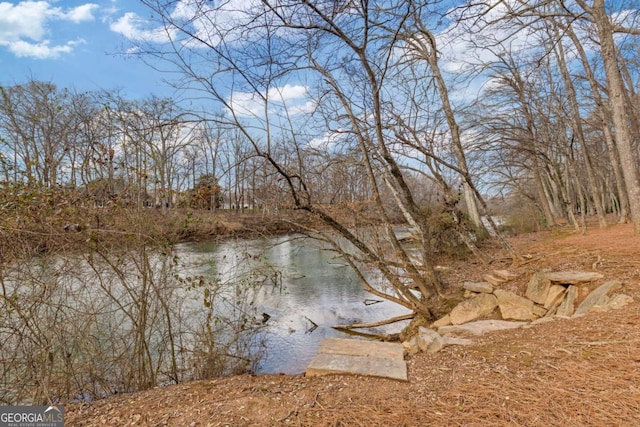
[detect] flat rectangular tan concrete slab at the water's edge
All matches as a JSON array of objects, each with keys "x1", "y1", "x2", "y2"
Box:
[{"x1": 305, "y1": 338, "x2": 408, "y2": 381}]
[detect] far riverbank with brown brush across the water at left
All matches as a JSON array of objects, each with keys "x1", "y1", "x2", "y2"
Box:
[{"x1": 0, "y1": 206, "x2": 308, "y2": 262}]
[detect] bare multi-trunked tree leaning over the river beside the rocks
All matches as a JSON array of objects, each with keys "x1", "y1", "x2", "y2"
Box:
[{"x1": 125, "y1": 0, "x2": 511, "y2": 317}]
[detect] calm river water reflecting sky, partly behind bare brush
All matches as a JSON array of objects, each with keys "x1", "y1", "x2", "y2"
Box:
[{"x1": 0, "y1": 236, "x2": 407, "y2": 404}]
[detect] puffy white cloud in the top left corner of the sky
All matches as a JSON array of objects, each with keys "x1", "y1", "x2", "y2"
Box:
[{"x1": 0, "y1": 1, "x2": 99, "y2": 59}]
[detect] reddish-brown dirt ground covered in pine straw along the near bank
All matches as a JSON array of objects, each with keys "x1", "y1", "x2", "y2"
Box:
[{"x1": 65, "y1": 225, "x2": 640, "y2": 427}]
